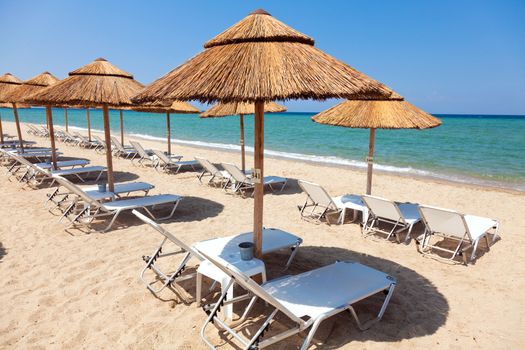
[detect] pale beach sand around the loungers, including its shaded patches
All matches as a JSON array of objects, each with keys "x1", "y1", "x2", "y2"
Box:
[{"x1": 0, "y1": 123, "x2": 525, "y2": 349}]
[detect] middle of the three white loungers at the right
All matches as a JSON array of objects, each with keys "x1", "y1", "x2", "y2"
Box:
[{"x1": 362, "y1": 195, "x2": 421, "y2": 244}]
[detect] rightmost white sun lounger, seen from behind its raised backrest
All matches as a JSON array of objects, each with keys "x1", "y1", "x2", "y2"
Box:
[{"x1": 419, "y1": 205, "x2": 499, "y2": 265}]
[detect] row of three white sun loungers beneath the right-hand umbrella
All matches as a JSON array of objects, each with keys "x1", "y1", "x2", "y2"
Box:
[{"x1": 299, "y1": 181, "x2": 499, "y2": 264}]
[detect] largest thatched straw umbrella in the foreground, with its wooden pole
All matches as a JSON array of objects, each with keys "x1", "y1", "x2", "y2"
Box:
[{"x1": 134, "y1": 10, "x2": 392, "y2": 257}]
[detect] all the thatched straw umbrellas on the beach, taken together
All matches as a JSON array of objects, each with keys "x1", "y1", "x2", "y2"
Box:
[{"x1": 0, "y1": 10, "x2": 440, "y2": 257}]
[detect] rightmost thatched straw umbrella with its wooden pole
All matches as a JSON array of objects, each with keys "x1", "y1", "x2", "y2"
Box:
[{"x1": 312, "y1": 96, "x2": 441, "y2": 194}]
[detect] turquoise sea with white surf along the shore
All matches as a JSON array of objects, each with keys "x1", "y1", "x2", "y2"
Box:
[{"x1": 0, "y1": 108, "x2": 525, "y2": 191}]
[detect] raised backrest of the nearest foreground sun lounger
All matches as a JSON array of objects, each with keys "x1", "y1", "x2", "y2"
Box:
[{"x1": 195, "y1": 247, "x2": 305, "y2": 324}]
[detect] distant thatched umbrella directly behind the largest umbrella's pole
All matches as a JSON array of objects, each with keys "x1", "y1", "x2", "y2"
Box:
[{"x1": 200, "y1": 102, "x2": 286, "y2": 171}]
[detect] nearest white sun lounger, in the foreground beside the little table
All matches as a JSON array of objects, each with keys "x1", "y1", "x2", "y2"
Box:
[{"x1": 197, "y1": 249, "x2": 396, "y2": 350}]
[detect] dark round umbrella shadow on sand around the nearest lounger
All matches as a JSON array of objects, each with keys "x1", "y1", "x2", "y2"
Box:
[{"x1": 253, "y1": 246, "x2": 449, "y2": 349}]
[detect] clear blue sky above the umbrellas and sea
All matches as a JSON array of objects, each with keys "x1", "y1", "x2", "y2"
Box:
[{"x1": 0, "y1": 0, "x2": 525, "y2": 114}]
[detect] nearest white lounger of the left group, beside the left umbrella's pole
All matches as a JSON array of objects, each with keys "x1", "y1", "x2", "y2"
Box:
[{"x1": 55, "y1": 176, "x2": 182, "y2": 232}]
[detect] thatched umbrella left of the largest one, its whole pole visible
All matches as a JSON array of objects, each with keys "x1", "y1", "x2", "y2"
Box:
[{"x1": 27, "y1": 58, "x2": 143, "y2": 191}]
